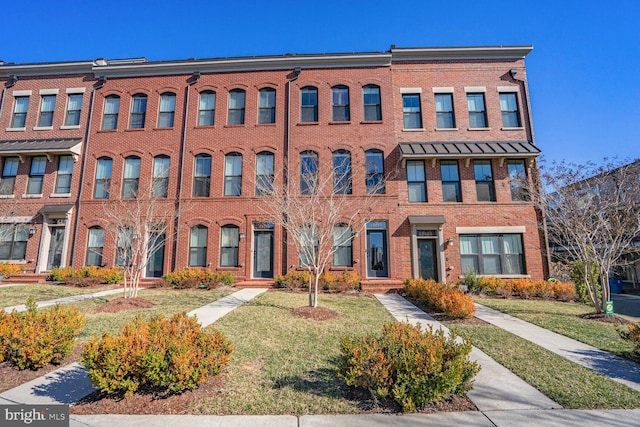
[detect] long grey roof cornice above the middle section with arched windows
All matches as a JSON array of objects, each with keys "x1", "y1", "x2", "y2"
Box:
[{"x1": 93, "y1": 52, "x2": 391, "y2": 77}]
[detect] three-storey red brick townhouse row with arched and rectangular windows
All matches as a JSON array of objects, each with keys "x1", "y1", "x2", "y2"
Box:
[{"x1": 0, "y1": 46, "x2": 546, "y2": 284}]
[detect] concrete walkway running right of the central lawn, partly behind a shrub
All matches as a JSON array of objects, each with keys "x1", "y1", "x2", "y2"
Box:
[{"x1": 375, "y1": 294, "x2": 561, "y2": 411}]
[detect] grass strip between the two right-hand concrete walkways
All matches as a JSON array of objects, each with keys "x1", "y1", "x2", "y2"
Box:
[{"x1": 456, "y1": 325, "x2": 640, "y2": 409}]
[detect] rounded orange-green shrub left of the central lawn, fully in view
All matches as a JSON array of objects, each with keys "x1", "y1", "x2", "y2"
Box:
[{"x1": 82, "y1": 313, "x2": 233, "y2": 396}]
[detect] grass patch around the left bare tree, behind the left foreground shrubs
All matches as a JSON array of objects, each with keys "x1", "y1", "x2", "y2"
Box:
[{"x1": 73, "y1": 289, "x2": 231, "y2": 342}]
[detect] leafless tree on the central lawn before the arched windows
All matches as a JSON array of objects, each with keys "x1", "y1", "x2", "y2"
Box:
[{"x1": 256, "y1": 152, "x2": 388, "y2": 307}]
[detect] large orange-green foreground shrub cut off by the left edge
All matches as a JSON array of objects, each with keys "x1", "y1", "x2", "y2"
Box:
[{"x1": 0, "y1": 298, "x2": 85, "y2": 370}]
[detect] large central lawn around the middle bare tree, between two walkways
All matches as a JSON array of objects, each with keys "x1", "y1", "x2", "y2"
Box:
[{"x1": 192, "y1": 292, "x2": 393, "y2": 415}]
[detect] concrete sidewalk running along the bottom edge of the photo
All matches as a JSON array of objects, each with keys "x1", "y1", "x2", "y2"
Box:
[{"x1": 65, "y1": 409, "x2": 640, "y2": 427}]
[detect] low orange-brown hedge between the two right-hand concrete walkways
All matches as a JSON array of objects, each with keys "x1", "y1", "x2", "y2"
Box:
[{"x1": 404, "y1": 279, "x2": 476, "y2": 319}]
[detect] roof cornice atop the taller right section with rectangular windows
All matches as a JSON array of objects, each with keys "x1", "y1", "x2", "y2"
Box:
[{"x1": 391, "y1": 45, "x2": 533, "y2": 62}]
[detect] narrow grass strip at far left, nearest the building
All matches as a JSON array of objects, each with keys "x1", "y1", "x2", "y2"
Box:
[{"x1": 0, "y1": 284, "x2": 114, "y2": 308}]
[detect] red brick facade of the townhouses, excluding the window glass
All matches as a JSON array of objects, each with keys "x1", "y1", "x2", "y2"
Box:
[{"x1": 0, "y1": 47, "x2": 546, "y2": 281}]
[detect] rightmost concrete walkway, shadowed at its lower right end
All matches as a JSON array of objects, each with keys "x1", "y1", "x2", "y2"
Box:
[{"x1": 475, "y1": 304, "x2": 640, "y2": 392}]
